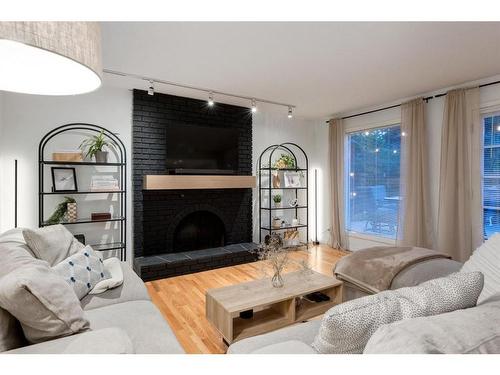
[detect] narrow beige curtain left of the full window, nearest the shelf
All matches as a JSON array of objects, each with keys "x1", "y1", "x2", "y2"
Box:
[{"x1": 329, "y1": 119, "x2": 347, "y2": 249}]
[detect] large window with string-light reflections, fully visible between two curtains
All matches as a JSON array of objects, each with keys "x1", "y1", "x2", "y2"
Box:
[{"x1": 345, "y1": 125, "x2": 401, "y2": 238}]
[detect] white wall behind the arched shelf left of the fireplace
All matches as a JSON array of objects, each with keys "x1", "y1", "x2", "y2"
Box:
[{"x1": 0, "y1": 87, "x2": 132, "y2": 259}]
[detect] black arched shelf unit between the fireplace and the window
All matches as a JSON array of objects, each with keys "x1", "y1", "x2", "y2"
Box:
[{"x1": 257, "y1": 142, "x2": 309, "y2": 248}]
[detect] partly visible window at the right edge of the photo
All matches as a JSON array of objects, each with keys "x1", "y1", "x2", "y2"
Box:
[{"x1": 483, "y1": 113, "x2": 500, "y2": 238}]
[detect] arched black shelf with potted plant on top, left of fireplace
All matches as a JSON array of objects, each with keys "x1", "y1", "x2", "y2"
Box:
[{"x1": 38, "y1": 123, "x2": 127, "y2": 261}]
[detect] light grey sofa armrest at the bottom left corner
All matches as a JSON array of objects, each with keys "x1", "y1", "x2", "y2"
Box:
[{"x1": 4, "y1": 328, "x2": 134, "y2": 354}]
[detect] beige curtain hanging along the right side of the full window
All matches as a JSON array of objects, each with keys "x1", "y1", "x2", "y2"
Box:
[{"x1": 398, "y1": 98, "x2": 434, "y2": 249}]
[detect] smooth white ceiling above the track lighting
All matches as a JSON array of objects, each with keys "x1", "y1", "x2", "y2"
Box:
[{"x1": 102, "y1": 22, "x2": 500, "y2": 118}]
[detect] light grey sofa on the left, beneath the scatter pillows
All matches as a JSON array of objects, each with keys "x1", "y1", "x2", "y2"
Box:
[{"x1": 0, "y1": 231, "x2": 184, "y2": 354}]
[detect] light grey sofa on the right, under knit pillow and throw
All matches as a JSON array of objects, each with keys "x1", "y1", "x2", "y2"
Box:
[{"x1": 228, "y1": 259, "x2": 500, "y2": 354}]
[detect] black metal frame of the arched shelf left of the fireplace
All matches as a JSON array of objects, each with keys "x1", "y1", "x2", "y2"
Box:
[{"x1": 38, "y1": 123, "x2": 127, "y2": 261}]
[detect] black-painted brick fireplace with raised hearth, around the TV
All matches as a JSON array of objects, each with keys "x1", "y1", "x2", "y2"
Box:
[{"x1": 132, "y1": 90, "x2": 256, "y2": 280}]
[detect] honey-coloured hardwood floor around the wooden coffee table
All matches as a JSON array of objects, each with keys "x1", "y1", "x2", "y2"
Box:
[{"x1": 146, "y1": 245, "x2": 347, "y2": 353}]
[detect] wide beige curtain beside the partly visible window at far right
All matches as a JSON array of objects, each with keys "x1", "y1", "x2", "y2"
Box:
[{"x1": 437, "y1": 88, "x2": 483, "y2": 262}]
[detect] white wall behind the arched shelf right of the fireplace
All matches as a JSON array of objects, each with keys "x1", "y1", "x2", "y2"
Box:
[{"x1": 253, "y1": 112, "x2": 329, "y2": 247}]
